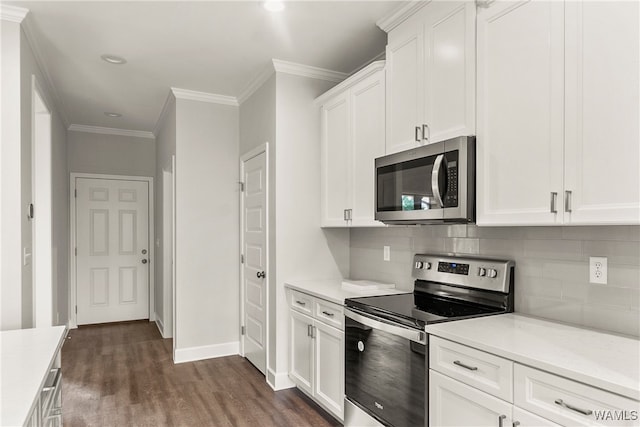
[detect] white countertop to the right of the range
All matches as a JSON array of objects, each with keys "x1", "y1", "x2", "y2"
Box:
[{"x1": 425, "y1": 314, "x2": 640, "y2": 400}]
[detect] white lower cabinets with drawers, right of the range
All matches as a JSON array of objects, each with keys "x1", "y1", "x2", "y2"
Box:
[{"x1": 429, "y1": 336, "x2": 640, "y2": 427}]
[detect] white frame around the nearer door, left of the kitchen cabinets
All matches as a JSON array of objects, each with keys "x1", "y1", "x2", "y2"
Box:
[{"x1": 238, "y1": 142, "x2": 271, "y2": 379}]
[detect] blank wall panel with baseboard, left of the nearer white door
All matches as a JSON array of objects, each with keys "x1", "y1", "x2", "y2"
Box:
[{"x1": 174, "y1": 99, "x2": 239, "y2": 361}]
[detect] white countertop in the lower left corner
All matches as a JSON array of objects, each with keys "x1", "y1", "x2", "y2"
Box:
[{"x1": 0, "y1": 326, "x2": 66, "y2": 426}]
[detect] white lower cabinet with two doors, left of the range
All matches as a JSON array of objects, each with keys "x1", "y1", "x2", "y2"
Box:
[{"x1": 288, "y1": 290, "x2": 344, "y2": 421}]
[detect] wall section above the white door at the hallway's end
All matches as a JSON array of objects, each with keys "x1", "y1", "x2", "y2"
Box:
[{"x1": 68, "y1": 131, "x2": 156, "y2": 177}]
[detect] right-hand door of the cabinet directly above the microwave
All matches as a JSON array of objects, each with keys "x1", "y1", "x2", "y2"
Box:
[{"x1": 423, "y1": 1, "x2": 476, "y2": 143}]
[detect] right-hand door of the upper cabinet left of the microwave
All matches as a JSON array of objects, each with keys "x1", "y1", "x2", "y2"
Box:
[{"x1": 350, "y1": 70, "x2": 385, "y2": 226}]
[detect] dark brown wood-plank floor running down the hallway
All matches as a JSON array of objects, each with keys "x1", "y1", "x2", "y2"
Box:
[{"x1": 62, "y1": 321, "x2": 340, "y2": 427}]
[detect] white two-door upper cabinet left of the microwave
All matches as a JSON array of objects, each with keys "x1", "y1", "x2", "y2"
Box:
[{"x1": 318, "y1": 61, "x2": 385, "y2": 227}]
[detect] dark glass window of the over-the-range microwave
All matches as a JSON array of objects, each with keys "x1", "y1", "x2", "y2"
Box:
[{"x1": 377, "y1": 156, "x2": 438, "y2": 212}]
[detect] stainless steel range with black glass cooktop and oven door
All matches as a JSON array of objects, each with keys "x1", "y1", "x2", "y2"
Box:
[{"x1": 344, "y1": 254, "x2": 514, "y2": 427}]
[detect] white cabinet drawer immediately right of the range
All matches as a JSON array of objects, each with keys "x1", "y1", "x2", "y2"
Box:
[{"x1": 429, "y1": 336, "x2": 513, "y2": 402}]
